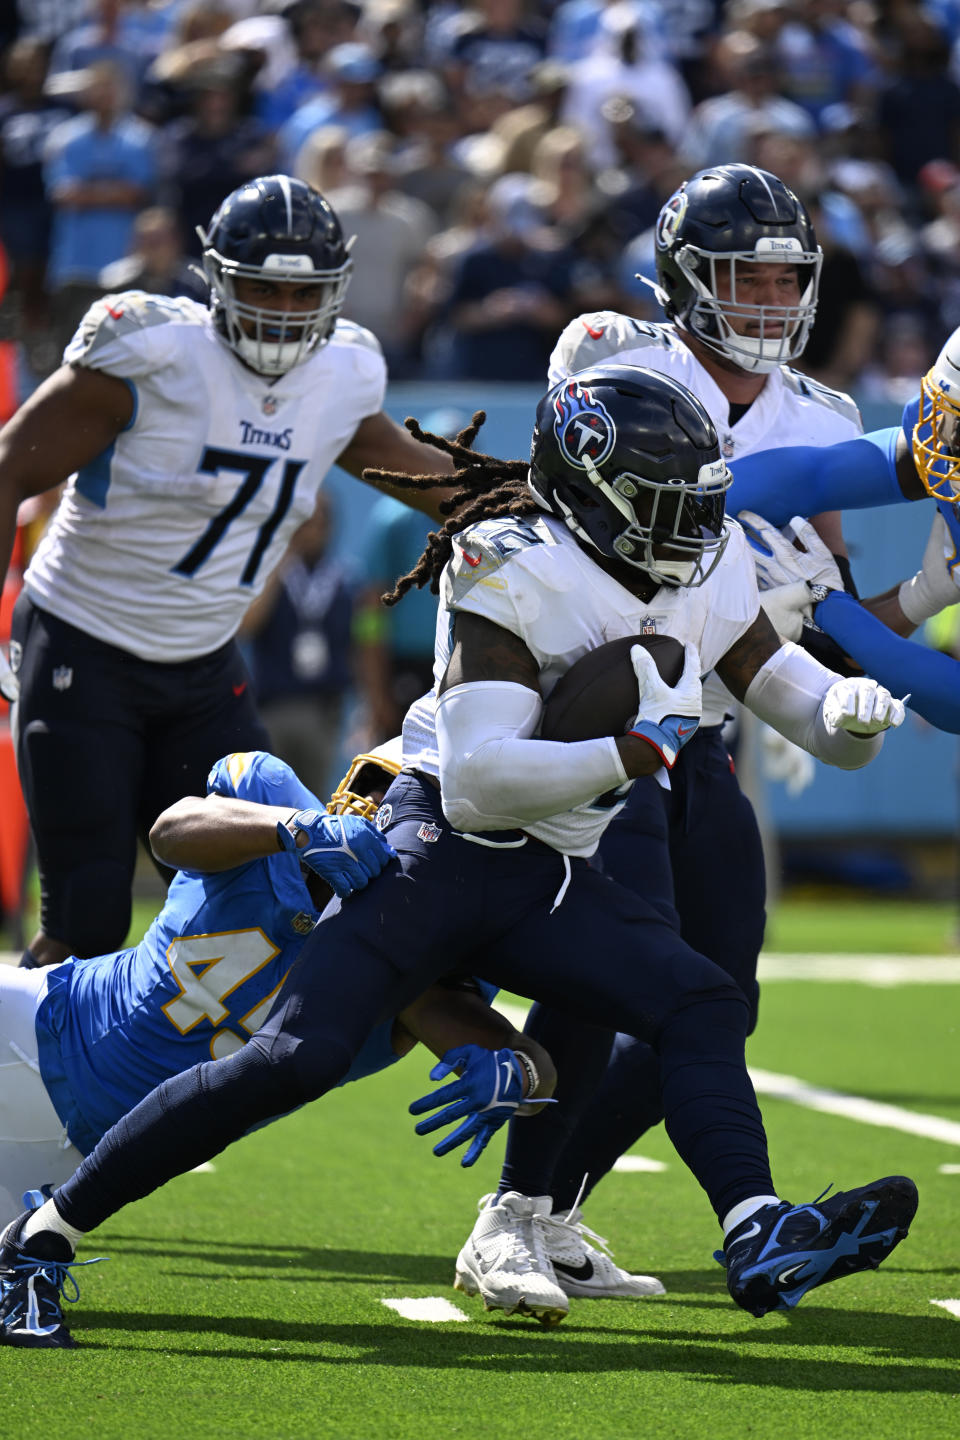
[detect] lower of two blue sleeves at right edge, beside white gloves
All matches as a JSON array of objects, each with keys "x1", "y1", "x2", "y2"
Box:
[{"x1": 813, "y1": 590, "x2": 960, "y2": 734}]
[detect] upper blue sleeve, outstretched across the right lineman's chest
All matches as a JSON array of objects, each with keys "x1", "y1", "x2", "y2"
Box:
[{"x1": 727, "y1": 426, "x2": 907, "y2": 526}]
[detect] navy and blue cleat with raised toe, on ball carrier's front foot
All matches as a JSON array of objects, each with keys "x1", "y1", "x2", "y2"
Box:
[{"x1": 717, "y1": 1175, "x2": 917, "y2": 1316}]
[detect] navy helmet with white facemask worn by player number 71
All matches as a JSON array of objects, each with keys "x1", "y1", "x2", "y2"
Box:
[{"x1": 197, "y1": 176, "x2": 353, "y2": 376}]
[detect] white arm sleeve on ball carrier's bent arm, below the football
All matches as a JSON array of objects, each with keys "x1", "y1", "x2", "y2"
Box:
[{"x1": 436, "y1": 680, "x2": 628, "y2": 831}]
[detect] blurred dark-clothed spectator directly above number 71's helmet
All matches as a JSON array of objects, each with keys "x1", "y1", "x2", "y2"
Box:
[{"x1": 160, "y1": 53, "x2": 275, "y2": 256}]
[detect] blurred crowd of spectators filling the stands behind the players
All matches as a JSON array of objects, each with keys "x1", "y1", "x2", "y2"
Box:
[{"x1": 0, "y1": 0, "x2": 960, "y2": 399}]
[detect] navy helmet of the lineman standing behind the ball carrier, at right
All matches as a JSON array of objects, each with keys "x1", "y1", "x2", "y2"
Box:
[{"x1": 655, "y1": 164, "x2": 823, "y2": 373}]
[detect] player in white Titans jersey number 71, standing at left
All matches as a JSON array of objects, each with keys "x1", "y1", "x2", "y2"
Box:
[{"x1": 0, "y1": 176, "x2": 445, "y2": 965}]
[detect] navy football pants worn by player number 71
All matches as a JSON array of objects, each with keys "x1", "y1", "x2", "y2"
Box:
[{"x1": 13, "y1": 592, "x2": 269, "y2": 955}]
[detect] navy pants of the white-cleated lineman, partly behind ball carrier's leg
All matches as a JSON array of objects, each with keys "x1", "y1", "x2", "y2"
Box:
[{"x1": 499, "y1": 727, "x2": 766, "y2": 1210}]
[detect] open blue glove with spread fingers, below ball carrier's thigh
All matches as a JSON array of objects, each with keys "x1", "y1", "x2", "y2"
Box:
[{"x1": 410, "y1": 1045, "x2": 524, "y2": 1165}]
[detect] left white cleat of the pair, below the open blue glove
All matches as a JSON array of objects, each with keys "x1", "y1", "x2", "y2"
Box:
[{"x1": 453, "y1": 1189, "x2": 570, "y2": 1326}]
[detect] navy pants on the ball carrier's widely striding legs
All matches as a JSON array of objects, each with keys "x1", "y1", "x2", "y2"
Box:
[{"x1": 55, "y1": 775, "x2": 773, "y2": 1230}]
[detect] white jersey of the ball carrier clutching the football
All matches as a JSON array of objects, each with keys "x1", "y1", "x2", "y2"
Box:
[{"x1": 403, "y1": 514, "x2": 760, "y2": 855}]
